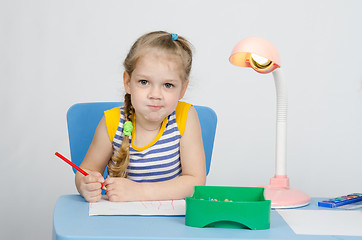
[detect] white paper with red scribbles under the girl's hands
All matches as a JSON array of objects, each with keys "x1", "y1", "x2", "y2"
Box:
[{"x1": 89, "y1": 198, "x2": 186, "y2": 216}]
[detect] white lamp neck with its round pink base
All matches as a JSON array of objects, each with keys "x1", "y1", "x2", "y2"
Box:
[{"x1": 262, "y1": 68, "x2": 310, "y2": 208}]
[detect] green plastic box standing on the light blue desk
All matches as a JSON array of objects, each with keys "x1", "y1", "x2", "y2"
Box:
[{"x1": 185, "y1": 186, "x2": 270, "y2": 230}]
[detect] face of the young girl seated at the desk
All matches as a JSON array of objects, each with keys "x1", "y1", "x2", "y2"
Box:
[{"x1": 123, "y1": 50, "x2": 188, "y2": 124}]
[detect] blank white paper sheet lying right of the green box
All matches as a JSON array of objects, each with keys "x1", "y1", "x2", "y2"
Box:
[{"x1": 277, "y1": 209, "x2": 362, "y2": 236}]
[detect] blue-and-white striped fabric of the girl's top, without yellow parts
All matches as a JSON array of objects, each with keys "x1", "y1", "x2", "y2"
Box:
[{"x1": 113, "y1": 106, "x2": 181, "y2": 182}]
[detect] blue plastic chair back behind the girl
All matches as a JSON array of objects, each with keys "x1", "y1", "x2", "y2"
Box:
[{"x1": 67, "y1": 102, "x2": 217, "y2": 177}]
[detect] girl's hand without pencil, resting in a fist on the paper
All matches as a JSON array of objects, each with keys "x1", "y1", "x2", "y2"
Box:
[{"x1": 104, "y1": 177, "x2": 140, "y2": 202}]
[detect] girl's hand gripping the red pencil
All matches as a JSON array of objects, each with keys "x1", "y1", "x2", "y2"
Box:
[{"x1": 78, "y1": 171, "x2": 104, "y2": 202}]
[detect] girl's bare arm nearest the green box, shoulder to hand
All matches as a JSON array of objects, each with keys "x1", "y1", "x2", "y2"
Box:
[{"x1": 105, "y1": 107, "x2": 206, "y2": 201}]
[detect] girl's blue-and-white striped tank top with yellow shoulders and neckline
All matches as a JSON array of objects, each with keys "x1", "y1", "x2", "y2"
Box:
[{"x1": 105, "y1": 102, "x2": 191, "y2": 182}]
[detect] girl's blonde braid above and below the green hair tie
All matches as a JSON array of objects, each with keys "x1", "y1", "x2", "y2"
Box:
[{"x1": 108, "y1": 93, "x2": 134, "y2": 177}]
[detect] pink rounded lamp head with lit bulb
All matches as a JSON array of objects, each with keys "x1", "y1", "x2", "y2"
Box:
[{"x1": 229, "y1": 37, "x2": 280, "y2": 73}]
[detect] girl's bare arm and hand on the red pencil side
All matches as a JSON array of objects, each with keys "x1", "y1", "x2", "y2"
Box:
[{"x1": 75, "y1": 117, "x2": 112, "y2": 202}]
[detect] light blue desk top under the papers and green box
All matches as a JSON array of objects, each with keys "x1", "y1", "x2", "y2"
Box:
[{"x1": 53, "y1": 195, "x2": 361, "y2": 240}]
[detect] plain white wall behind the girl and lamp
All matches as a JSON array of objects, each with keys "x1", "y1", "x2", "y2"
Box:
[{"x1": 0, "y1": 0, "x2": 362, "y2": 239}]
